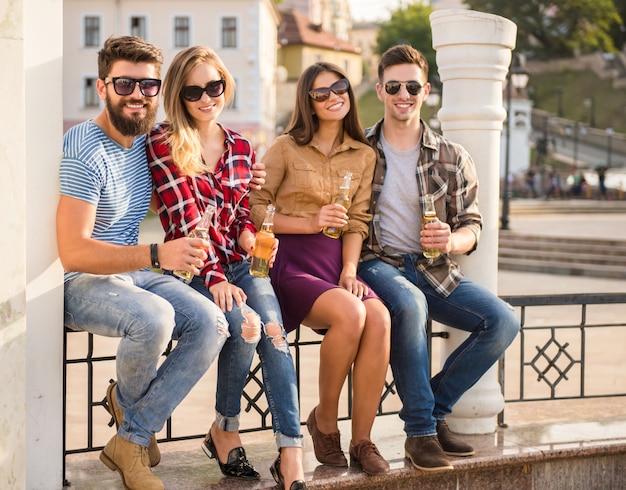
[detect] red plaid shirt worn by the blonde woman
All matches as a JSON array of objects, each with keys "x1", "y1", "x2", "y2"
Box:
[{"x1": 146, "y1": 123, "x2": 256, "y2": 288}]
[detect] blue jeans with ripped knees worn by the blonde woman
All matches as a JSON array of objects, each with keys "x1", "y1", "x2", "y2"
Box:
[{"x1": 190, "y1": 260, "x2": 302, "y2": 448}]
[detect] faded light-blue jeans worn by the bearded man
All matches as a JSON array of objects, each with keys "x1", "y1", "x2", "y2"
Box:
[{"x1": 65, "y1": 270, "x2": 228, "y2": 447}]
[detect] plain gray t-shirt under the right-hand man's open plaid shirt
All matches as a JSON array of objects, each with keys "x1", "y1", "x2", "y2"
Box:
[{"x1": 378, "y1": 131, "x2": 422, "y2": 253}]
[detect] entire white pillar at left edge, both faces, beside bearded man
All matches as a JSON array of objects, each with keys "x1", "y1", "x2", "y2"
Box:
[{"x1": 0, "y1": 0, "x2": 63, "y2": 490}]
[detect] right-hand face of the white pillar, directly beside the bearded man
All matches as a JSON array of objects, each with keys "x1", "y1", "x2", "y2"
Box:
[{"x1": 23, "y1": 0, "x2": 63, "y2": 490}]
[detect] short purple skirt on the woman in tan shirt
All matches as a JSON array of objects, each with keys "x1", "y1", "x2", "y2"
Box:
[{"x1": 270, "y1": 233, "x2": 378, "y2": 333}]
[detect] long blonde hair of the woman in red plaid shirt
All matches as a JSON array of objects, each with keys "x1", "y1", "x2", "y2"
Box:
[{"x1": 163, "y1": 46, "x2": 235, "y2": 177}]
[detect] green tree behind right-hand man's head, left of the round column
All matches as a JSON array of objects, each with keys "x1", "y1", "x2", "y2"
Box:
[{"x1": 377, "y1": 3, "x2": 440, "y2": 85}]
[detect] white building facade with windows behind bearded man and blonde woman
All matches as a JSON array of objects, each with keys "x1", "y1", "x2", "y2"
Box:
[{"x1": 63, "y1": 0, "x2": 280, "y2": 147}]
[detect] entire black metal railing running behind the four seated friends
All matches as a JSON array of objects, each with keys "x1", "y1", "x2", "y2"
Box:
[{"x1": 63, "y1": 293, "x2": 626, "y2": 484}]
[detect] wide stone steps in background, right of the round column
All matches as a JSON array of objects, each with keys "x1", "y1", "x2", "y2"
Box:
[{"x1": 498, "y1": 230, "x2": 626, "y2": 279}]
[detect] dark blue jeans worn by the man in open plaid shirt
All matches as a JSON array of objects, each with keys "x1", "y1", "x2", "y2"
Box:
[{"x1": 359, "y1": 254, "x2": 520, "y2": 437}]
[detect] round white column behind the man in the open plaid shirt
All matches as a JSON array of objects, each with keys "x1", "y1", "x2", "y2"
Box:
[{"x1": 430, "y1": 10, "x2": 517, "y2": 434}]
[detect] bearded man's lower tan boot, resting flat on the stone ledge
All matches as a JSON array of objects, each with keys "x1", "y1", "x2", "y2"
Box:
[{"x1": 100, "y1": 434, "x2": 165, "y2": 490}]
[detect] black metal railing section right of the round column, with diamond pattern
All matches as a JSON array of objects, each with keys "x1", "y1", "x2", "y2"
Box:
[{"x1": 498, "y1": 293, "x2": 626, "y2": 426}]
